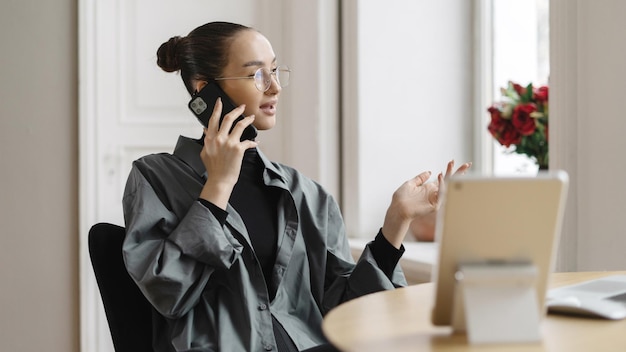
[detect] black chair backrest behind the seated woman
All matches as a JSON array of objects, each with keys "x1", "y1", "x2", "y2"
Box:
[{"x1": 88, "y1": 223, "x2": 153, "y2": 352}]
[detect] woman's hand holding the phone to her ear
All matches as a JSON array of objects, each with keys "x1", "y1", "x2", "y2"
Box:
[{"x1": 200, "y1": 98, "x2": 257, "y2": 209}]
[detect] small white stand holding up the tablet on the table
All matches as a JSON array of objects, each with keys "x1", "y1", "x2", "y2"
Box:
[{"x1": 452, "y1": 263, "x2": 541, "y2": 344}]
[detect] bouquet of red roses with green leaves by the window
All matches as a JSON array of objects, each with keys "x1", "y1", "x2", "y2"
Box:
[{"x1": 487, "y1": 82, "x2": 548, "y2": 169}]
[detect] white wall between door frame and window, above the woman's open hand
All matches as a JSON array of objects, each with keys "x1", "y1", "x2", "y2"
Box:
[{"x1": 343, "y1": 0, "x2": 473, "y2": 237}]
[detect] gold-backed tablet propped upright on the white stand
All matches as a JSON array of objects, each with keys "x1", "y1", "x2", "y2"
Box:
[{"x1": 431, "y1": 171, "x2": 568, "y2": 325}]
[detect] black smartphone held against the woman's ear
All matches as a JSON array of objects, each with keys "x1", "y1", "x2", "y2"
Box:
[{"x1": 188, "y1": 82, "x2": 257, "y2": 141}]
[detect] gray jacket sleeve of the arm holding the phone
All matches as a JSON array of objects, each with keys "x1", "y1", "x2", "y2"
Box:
[{"x1": 122, "y1": 167, "x2": 243, "y2": 318}]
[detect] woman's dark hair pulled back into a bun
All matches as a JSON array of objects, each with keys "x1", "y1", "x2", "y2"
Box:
[{"x1": 157, "y1": 22, "x2": 252, "y2": 94}]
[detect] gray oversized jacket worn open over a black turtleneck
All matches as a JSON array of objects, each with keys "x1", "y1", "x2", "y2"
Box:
[{"x1": 123, "y1": 136, "x2": 406, "y2": 351}]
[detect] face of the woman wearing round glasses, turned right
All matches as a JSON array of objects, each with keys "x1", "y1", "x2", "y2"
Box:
[{"x1": 218, "y1": 30, "x2": 281, "y2": 130}]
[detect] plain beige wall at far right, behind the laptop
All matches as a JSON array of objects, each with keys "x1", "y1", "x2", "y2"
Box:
[{"x1": 550, "y1": 0, "x2": 626, "y2": 271}]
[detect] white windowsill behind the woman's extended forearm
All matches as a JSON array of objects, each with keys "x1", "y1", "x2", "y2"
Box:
[{"x1": 349, "y1": 238, "x2": 439, "y2": 285}]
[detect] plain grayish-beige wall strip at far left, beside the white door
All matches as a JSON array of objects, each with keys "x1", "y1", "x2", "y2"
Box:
[{"x1": 0, "y1": 0, "x2": 79, "y2": 352}]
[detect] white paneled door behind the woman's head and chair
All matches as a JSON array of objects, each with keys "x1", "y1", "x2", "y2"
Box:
[{"x1": 79, "y1": 0, "x2": 290, "y2": 352}]
